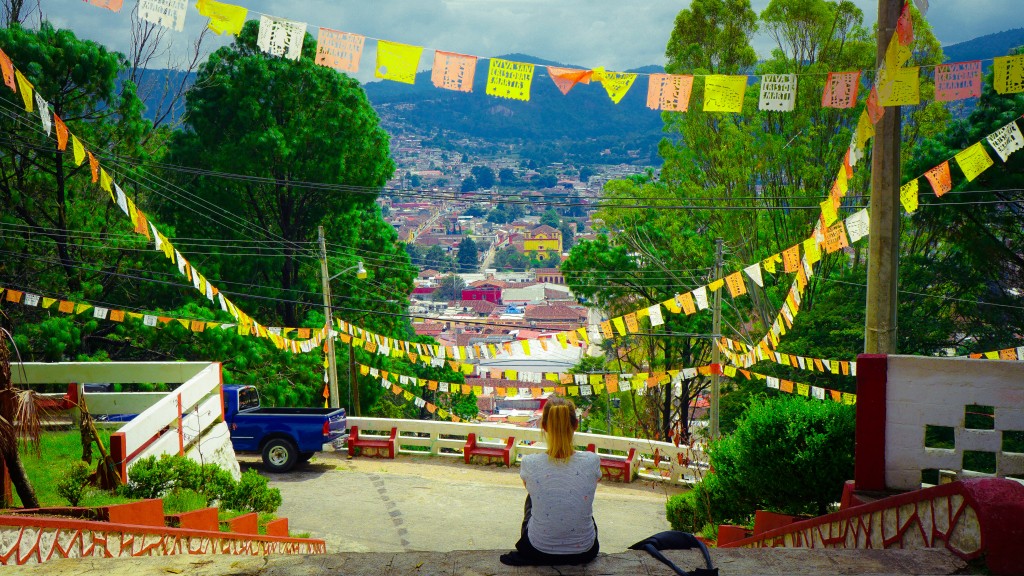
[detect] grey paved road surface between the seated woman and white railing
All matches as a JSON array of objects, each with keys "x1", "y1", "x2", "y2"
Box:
[{"x1": 243, "y1": 453, "x2": 678, "y2": 552}]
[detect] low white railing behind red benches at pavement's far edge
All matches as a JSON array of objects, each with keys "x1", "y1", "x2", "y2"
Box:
[{"x1": 348, "y1": 416, "x2": 709, "y2": 484}]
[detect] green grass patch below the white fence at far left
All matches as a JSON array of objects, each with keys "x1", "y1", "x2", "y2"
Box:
[{"x1": 14, "y1": 429, "x2": 133, "y2": 506}]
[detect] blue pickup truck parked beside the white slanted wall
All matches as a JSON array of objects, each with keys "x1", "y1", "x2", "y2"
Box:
[{"x1": 224, "y1": 385, "x2": 347, "y2": 472}]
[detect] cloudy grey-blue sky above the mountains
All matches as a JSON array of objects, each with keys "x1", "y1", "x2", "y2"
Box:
[{"x1": 39, "y1": 0, "x2": 1024, "y2": 81}]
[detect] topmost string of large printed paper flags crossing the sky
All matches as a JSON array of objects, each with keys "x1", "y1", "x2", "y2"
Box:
[{"x1": 74, "y1": 0, "x2": 1024, "y2": 113}]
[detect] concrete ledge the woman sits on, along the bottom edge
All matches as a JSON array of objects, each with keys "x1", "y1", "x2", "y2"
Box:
[{"x1": 3, "y1": 548, "x2": 972, "y2": 576}]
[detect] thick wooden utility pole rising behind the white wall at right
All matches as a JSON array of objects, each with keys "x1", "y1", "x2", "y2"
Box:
[{"x1": 864, "y1": 0, "x2": 903, "y2": 354}]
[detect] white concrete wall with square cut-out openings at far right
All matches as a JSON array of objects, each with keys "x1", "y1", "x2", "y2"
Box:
[{"x1": 885, "y1": 356, "x2": 1024, "y2": 490}]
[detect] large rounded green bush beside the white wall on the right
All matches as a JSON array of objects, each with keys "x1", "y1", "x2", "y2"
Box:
[{"x1": 709, "y1": 397, "x2": 855, "y2": 517}]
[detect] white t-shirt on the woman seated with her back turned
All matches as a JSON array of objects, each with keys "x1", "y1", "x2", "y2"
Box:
[{"x1": 519, "y1": 452, "x2": 601, "y2": 554}]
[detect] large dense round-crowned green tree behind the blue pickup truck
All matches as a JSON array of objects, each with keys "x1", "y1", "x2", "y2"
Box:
[{"x1": 163, "y1": 20, "x2": 394, "y2": 326}]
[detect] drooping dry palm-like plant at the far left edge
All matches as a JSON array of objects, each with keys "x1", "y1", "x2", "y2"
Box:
[{"x1": 0, "y1": 328, "x2": 42, "y2": 508}]
